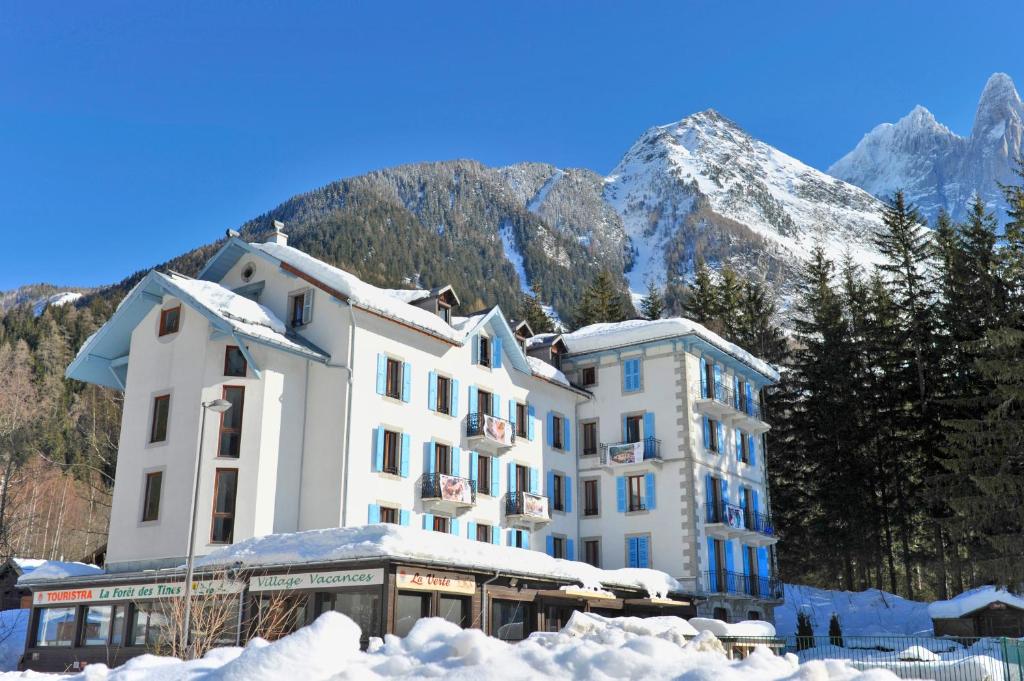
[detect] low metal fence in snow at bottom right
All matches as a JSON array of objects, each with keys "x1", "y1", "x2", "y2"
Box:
[{"x1": 785, "y1": 636, "x2": 1024, "y2": 681}]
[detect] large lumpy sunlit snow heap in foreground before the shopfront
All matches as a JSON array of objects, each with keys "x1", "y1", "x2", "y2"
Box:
[{"x1": 0, "y1": 612, "x2": 896, "y2": 681}]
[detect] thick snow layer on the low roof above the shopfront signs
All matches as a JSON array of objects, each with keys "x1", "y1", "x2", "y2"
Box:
[{"x1": 197, "y1": 524, "x2": 682, "y2": 598}]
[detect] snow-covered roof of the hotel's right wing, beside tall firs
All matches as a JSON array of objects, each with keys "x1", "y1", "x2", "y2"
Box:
[{"x1": 562, "y1": 316, "x2": 778, "y2": 381}]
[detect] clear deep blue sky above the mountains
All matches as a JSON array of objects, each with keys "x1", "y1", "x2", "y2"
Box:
[{"x1": 0, "y1": 0, "x2": 1024, "y2": 290}]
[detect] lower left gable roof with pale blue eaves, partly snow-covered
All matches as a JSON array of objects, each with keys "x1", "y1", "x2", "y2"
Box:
[{"x1": 65, "y1": 270, "x2": 330, "y2": 390}]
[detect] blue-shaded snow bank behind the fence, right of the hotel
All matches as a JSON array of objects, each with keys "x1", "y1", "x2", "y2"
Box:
[{"x1": 775, "y1": 584, "x2": 932, "y2": 636}]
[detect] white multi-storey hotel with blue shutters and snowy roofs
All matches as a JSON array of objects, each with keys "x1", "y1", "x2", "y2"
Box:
[{"x1": 29, "y1": 225, "x2": 780, "y2": 663}]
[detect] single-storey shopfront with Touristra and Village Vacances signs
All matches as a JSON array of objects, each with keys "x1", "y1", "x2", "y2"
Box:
[{"x1": 22, "y1": 559, "x2": 696, "y2": 672}]
